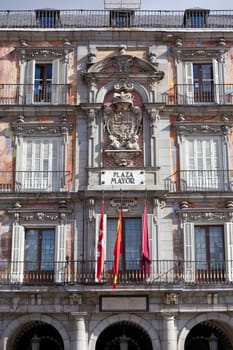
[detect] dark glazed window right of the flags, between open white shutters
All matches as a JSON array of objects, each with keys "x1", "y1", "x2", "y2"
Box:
[{"x1": 194, "y1": 226, "x2": 225, "y2": 279}]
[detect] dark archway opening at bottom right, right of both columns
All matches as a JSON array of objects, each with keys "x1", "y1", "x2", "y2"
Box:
[{"x1": 185, "y1": 321, "x2": 233, "y2": 350}]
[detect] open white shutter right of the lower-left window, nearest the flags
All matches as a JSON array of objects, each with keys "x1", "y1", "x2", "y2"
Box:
[{"x1": 55, "y1": 225, "x2": 66, "y2": 283}]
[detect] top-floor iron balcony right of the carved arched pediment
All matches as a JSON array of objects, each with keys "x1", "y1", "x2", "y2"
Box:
[{"x1": 163, "y1": 83, "x2": 233, "y2": 105}]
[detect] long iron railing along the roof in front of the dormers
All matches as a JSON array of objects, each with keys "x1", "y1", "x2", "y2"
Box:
[{"x1": 0, "y1": 10, "x2": 233, "y2": 29}]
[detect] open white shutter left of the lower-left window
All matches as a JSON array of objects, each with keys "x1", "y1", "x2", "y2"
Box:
[{"x1": 11, "y1": 224, "x2": 25, "y2": 283}]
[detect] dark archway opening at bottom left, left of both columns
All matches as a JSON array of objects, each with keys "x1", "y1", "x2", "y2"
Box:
[{"x1": 12, "y1": 321, "x2": 64, "y2": 350}]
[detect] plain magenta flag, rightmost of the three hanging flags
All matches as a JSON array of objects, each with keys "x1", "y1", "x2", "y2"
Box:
[{"x1": 142, "y1": 203, "x2": 151, "y2": 276}]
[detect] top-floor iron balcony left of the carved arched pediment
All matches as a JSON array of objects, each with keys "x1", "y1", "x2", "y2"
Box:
[{"x1": 0, "y1": 84, "x2": 70, "y2": 105}]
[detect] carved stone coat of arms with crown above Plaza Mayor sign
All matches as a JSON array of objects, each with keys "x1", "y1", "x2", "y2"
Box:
[{"x1": 104, "y1": 91, "x2": 142, "y2": 166}]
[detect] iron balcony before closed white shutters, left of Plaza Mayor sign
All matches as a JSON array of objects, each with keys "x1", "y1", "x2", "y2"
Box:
[{"x1": 0, "y1": 171, "x2": 71, "y2": 193}]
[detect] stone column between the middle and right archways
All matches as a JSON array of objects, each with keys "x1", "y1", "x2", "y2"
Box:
[{"x1": 163, "y1": 314, "x2": 177, "y2": 350}]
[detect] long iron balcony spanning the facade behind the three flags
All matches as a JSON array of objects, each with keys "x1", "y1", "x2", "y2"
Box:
[{"x1": 0, "y1": 259, "x2": 233, "y2": 286}]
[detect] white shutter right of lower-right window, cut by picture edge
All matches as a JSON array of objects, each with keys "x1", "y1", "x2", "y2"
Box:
[{"x1": 224, "y1": 222, "x2": 233, "y2": 282}]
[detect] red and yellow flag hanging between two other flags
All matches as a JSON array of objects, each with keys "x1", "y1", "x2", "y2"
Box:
[{"x1": 112, "y1": 208, "x2": 122, "y2": 289}]
